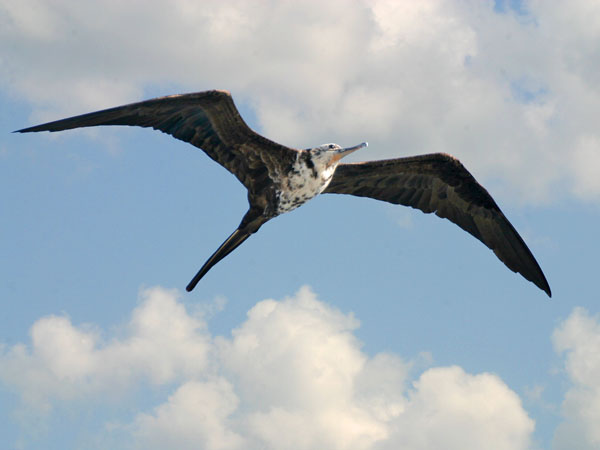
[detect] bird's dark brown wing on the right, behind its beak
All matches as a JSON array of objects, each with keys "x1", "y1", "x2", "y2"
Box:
[{"x1": 324, "y1": 153, "x2": 551, "y2": 296}]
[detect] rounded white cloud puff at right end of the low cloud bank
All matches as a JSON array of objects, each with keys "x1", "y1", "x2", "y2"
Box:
[{"x1": 383, "y1": 366, "x2": 534, "y2": 450}]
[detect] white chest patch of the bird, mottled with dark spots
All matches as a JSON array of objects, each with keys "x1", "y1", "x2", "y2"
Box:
[{"x1": 277, "y1": 159, "x2": 335, "y2": 214}]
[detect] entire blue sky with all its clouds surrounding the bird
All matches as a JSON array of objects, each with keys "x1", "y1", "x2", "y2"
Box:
[{"x1": 0, "y1": 0, "x2": 600, "y2": 450}]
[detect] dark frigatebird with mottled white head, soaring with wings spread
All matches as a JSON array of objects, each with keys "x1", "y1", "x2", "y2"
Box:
[{"x1": 16, "y1": 90, "x2": 552, "y2": 296}]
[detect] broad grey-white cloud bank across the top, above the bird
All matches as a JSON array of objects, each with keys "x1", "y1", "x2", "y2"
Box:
[{"x1": 0, "y1": 0, "x2": 600, "y2": 202}]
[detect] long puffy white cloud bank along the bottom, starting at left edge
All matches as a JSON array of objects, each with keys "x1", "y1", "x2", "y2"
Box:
[{"x1": 0, "y1": 287, "x2": 534, "y2": 450}]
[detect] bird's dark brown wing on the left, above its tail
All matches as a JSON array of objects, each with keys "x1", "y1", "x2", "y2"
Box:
[{"x1": 18, "y1": 91, "x2": 296, "y2": 191}]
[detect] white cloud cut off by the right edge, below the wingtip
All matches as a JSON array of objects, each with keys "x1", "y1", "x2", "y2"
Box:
[{"x1": 553, "y1": 308, "x2": 600, "y2": 450}]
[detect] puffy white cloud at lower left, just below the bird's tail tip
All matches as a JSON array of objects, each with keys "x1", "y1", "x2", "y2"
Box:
[{"x1": 0, "y1": 288, "x2": 209, "y2": 411}]
